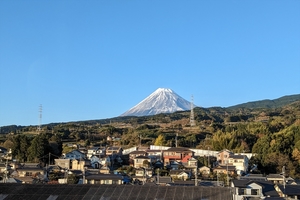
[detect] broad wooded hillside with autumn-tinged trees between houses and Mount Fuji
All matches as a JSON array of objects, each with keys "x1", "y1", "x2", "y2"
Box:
[{"x1": 0, "y1": 94, "x2": 300, "y2": 178}]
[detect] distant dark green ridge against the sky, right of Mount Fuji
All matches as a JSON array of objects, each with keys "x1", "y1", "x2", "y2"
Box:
[{"x1": 228, "y1": 94, "x2": 300, "y2": 109}]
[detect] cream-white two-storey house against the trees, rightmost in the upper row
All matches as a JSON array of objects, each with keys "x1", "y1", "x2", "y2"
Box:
[{"x1": 228, "y1": 154, "x2": 249, "y2": 175}]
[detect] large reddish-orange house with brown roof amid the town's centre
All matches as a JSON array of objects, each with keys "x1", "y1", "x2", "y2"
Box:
[{"x1": 163, "y1": 147, "x2": 194, "y2": 165}]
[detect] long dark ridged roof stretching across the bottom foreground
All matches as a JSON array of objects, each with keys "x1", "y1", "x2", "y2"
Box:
[{"x1": 0, "y1": 184, "x2": 232, "y2": 200}]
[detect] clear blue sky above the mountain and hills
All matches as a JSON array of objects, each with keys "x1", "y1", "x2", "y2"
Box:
[{"x1": 0, "y1": 0, "x2": 300, "y2": 126}]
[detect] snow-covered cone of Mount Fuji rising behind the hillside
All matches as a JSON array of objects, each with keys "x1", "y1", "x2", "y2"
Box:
[{"x1": 121, "y1": 88, "x2": 191, "y2": 116}]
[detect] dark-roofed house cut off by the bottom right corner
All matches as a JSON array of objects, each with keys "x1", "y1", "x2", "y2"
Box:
[{"x1": 275, "y1": 184, "x2": 300, "y2": 199}]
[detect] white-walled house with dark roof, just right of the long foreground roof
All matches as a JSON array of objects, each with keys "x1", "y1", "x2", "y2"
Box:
[{"x1": 231, "y1": 180, "x2": 279, "y2": 200}]
